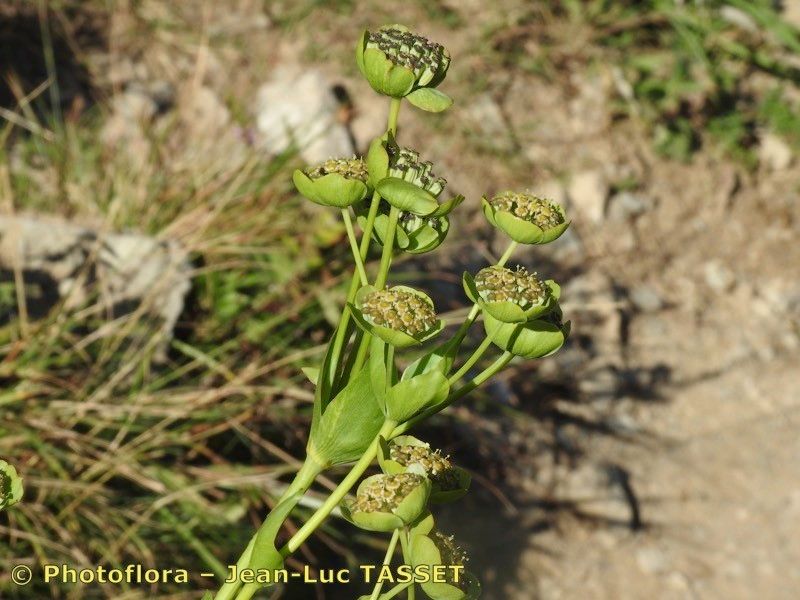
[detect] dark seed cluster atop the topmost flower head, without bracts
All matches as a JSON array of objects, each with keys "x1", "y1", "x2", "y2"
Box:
[{"x1": 367, "y1": 27, "x2": 450, "y2": 85}]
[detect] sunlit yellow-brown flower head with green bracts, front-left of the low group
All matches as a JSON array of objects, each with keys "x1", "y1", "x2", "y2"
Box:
[{"x1": 342, "y1": 473, "x2": 431, "y2": 531}]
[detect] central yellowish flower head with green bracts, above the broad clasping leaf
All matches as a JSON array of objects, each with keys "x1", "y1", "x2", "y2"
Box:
[{"x1": 351, "y1": 285, "x2": 444, "y2": 348}]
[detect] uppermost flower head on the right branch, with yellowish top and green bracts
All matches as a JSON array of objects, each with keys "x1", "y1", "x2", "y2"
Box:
[{"x1": 481, "y1": 192, "x2": 569, "y2": 244}]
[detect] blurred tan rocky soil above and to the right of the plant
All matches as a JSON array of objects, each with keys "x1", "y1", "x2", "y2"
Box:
[{"x1": 6, "y1": 2, "x2": 800, "y2": 600}]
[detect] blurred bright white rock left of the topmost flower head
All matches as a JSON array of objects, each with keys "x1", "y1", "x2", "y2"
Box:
[{"x1": 256, "y1": 65, "x2": 355, "y2": 163}]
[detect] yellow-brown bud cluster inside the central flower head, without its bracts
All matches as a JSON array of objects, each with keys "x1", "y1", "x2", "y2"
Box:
[{"x1": 361, "y1": 289, "x2": 437, "y2": 337}]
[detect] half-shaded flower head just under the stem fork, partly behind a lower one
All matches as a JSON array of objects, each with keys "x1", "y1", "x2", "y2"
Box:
[{"x1": 378, "y1": 435, "x2": 471, "y2": 504}]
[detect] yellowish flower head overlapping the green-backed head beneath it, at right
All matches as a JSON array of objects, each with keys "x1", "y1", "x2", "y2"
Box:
[{"x1": 463, "y1": 265, "x2": 560, "y2": 323}]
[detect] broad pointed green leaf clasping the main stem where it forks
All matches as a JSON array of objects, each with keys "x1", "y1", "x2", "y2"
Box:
[{"x1": 308, "y1": 365, "x2": 384, "y2": 466}]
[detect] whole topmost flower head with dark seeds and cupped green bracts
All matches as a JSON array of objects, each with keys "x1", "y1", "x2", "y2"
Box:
[{"x1": 356, "y1": 25, "x2": 452, "y2": 106}]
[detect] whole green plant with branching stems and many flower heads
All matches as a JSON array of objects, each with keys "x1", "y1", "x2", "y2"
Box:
[{"x1": 215, "y1": 25, "x2": 569, "y2": 600}]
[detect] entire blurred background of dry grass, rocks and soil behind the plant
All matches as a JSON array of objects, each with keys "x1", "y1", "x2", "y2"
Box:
[{"x1": 0, "y1": 0, "x2": 800, "y2": 600}]
